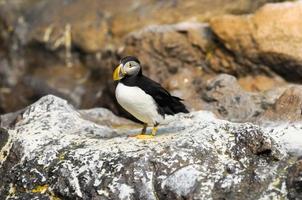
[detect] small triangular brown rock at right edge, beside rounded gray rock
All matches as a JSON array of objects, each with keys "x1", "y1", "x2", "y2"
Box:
[{"x1": 260, "y1": 86, "x2": 302, "y2": 121}]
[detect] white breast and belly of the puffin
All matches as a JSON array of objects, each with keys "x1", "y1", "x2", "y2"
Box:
[{"x1": 115, "y1": 83, "x2": 163, "y2": 124}]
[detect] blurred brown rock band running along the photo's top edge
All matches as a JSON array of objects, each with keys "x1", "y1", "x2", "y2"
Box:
[{"x1": 0, "y1": 0, "x2": 278, "y2": 52}]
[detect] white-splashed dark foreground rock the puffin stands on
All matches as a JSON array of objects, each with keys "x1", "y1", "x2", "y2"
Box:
[{"x1": 0, "y1": 95, "x2": 297, "y2": 200}]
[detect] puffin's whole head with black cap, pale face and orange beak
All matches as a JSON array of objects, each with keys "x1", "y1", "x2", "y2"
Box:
[{"x1": 113, "y1": 56, "x2": 142, "y2": 81}]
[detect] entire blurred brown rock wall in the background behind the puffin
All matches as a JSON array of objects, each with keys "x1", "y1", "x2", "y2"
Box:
[{"x1": 0, "y1": 0, "x2": 302, "y2": 121}]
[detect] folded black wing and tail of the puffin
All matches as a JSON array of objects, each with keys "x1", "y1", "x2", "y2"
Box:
[{"x1": 136, "y1": 75, "x2": 189, "y2": 115}]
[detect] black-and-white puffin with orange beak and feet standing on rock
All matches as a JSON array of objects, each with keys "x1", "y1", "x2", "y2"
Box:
[{"x1": 113, "y1": 56, "x2": 189, "y2": 139}]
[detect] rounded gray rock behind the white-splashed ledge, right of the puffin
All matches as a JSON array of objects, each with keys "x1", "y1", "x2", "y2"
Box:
[{"x1": 201, "y1": 74, "x2": 285, "y2": 122}]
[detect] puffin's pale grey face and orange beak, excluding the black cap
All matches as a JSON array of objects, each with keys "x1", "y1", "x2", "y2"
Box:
[{"x1": 113, "y1": 60, "x2": 141, "y2": 81}]
